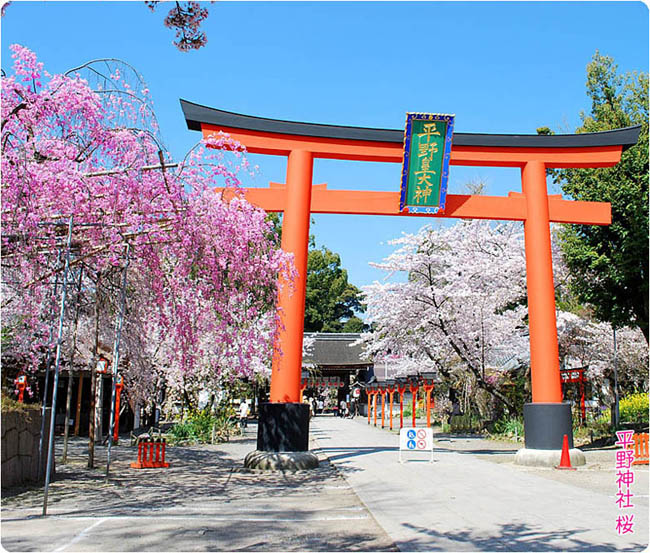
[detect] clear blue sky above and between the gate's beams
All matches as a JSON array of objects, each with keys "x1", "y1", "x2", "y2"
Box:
[{"x1": 1, "y1": 1, "x2": 649, "y2": 286}]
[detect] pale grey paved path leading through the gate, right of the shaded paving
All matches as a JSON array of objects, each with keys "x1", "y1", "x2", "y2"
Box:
[{"x1": 311, "y1": 417, "x2": 648, "y2": 551}]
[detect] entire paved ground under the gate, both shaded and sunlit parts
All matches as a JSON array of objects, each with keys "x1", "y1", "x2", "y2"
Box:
[{"x1": 0, "y1": 416, "x2": 648, "y2": 551}]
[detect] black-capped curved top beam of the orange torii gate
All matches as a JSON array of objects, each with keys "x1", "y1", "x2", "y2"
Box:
[{"x1": 180, "y1": 100, "x2": 641, "y2": 168}]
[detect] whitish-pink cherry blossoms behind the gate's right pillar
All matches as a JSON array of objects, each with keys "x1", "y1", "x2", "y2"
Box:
[{"x1": 363, "y1": 221, "x2": 648, "y2": 412}]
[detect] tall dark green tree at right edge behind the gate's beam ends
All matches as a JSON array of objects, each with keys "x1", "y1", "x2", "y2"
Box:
[{"x1": 538, "y1": 52, "x2": 648, "y2": 340}]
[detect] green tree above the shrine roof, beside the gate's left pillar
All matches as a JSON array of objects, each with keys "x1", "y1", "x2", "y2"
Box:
[{"x1": 305, "y1": 246, "x2": 365, "y2": 332}]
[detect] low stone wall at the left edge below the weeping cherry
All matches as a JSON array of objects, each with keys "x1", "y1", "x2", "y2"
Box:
[{"x1": 0, "y1": 409, "x2": 55, "y2": 488}]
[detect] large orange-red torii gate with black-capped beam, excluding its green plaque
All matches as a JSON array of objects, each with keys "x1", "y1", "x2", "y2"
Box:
[{"x1": 181, "y1": 100, "x2": 640, "y2": 458}]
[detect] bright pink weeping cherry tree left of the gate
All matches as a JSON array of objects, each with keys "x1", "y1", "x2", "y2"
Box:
[{"x1": 1, "y1": 45, "x2": 293, "y2": 410}]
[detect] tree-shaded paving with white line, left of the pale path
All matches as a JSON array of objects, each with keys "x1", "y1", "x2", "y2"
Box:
[{"x1": 0, "y1": 425, "x2": 396, "y2": 551}]
